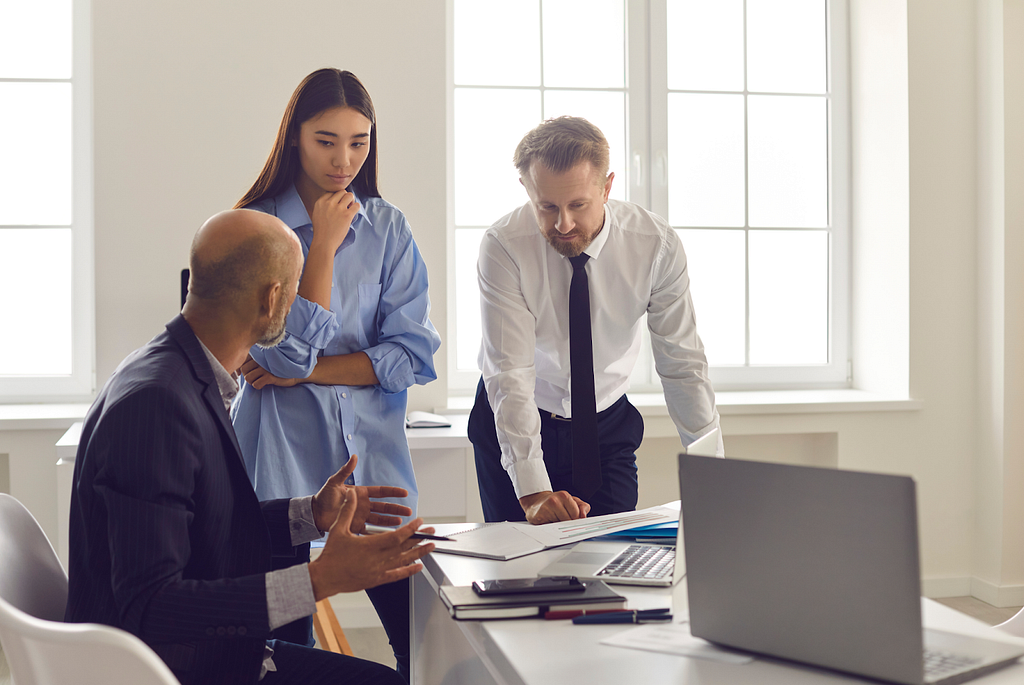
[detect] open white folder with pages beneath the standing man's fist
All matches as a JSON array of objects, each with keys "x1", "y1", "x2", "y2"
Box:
[{"x1": 434, "y1": 506, "x2": 679, "y2": 561}]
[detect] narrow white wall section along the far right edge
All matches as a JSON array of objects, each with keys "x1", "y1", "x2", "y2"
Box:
[{"x1": 974, "y1": 0, "x2": 1024, "y2": 601}]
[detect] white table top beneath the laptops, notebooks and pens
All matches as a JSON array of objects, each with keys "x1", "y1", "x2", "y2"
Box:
[{"x1": 424, "y1": 536, "x2": 1024, "y2": 685}]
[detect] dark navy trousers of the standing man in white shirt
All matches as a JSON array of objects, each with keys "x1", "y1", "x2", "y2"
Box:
[{"x1": 469, "y1": 379, "x2": 643, "y2": 521}]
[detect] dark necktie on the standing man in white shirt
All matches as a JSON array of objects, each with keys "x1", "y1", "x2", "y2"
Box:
[{"x1": 569, "y1": 254, "x2": 601, "y2": 493}]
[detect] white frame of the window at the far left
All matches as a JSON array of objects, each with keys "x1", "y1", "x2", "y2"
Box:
[{"x1": 0, "y1": 0, "x2": 96, "y2": 403}]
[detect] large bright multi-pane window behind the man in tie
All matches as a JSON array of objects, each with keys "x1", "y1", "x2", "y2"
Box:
[{"x1": 450, "y1": 0, "x2": 849, "y2": 392}]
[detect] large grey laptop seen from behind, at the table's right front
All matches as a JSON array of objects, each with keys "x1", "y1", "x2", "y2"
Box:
[{"x1": 679, "y1": 455, "x2": 1024, "y2": 685}]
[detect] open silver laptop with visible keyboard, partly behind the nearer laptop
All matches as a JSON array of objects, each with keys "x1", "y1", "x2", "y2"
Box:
[{"x1": 540, "y1": 428, "x2": 719, "y2": 588}]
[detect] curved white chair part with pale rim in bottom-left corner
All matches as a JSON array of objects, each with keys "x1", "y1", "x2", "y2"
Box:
[{"x1": 0, "y1": 599, "x2": 179, "y2": 685}]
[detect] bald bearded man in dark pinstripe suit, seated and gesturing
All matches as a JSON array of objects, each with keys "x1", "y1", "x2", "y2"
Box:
[{"x1": 66, "y1": 210, "x2": 432, "y2": 685}]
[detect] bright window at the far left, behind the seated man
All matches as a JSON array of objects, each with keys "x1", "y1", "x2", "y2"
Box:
[{"x1": 0, "y1": 0, "x2": 93, "y2": 401}]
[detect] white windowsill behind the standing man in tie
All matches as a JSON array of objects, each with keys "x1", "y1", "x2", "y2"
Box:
[{"x1": 434, "y1": 389, "x2": 924, "y2": 418}]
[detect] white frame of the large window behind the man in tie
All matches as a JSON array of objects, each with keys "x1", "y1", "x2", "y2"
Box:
[{"x1": 446, "y1": 0, "x2": 853, "y2": 396}]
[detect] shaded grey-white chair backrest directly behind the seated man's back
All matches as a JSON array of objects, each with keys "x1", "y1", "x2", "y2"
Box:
[{"x1": 0, "y1": 493, "x2": 68, "y2": 620}]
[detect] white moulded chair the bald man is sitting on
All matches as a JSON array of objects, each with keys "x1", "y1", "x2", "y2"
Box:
[{"x1": 0, "y1": 494, "x2": 179, "y2": 685}]
